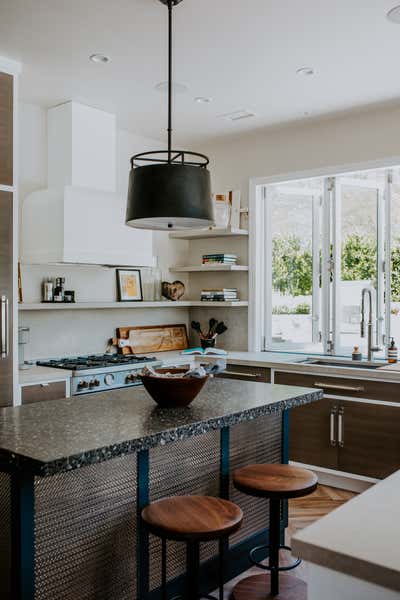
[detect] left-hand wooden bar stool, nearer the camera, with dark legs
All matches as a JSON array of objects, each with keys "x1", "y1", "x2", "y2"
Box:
[{"x1": 142, "y1": 496, "x2": 243, "y2": 600}]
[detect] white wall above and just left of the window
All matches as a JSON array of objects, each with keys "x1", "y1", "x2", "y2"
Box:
[{"x1": 199, "y1": 102, "x2": 400, "y2": 349}]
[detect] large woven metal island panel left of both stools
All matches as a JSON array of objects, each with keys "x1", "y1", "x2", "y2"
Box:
[{"x1": 35, "y1": 454, "x2": 137, "y2": 600}]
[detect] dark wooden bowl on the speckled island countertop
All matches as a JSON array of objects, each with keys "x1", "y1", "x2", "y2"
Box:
[{"x1": 142, "y1": 368, "x2": 208, "y2": 408}]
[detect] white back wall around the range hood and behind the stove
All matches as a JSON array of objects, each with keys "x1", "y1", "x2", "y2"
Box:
[{"x1": 18, "y1": 103, "x2": 188, "y2": 358}]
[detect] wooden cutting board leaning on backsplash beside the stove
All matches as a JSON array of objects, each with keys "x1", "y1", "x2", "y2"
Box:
[{"x1": 117, "y1": 324, "x2": 188, "y2": 354}]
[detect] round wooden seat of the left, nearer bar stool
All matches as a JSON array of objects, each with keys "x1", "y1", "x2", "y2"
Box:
[{"x1": 142, "y1": 496, "x2": 243, "y2": 542}]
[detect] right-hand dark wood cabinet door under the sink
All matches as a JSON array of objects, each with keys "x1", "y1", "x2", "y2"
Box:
[{"x1": 338, "y1": 401, "x2": 400, "y2": 479}]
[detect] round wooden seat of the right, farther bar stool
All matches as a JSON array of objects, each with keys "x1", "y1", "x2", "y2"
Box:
[{"x1": 233, "y1": 464, "x2": 318, "y2": 500}]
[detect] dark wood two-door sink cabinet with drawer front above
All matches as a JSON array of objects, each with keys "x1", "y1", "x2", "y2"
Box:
[{"x1": 274, "y1": 373, "x2": 400, "y2": 479}]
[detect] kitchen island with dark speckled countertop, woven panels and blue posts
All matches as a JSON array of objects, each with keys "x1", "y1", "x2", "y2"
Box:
[{"x1": 0, "y1": 379, "x2": 322, "y2": 600}]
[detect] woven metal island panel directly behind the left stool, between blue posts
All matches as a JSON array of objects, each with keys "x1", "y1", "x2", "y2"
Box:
[{"x1": 150, "y1": 431, "x2": 220, "y2": 590}]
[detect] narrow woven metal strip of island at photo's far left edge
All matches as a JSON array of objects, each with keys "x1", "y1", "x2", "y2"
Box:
[{"x1": 0, "y1": 473, "x2": 12, "y2": 600}]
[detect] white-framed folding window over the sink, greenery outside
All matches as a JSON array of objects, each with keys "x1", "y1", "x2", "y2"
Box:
[{"x1": 256, "y1": 167, "x2": 400, "y2": 356}]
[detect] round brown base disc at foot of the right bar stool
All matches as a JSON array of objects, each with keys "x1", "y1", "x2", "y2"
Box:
[{"x1": 232, "y1": 575, "x2": 307, "y2": 600}]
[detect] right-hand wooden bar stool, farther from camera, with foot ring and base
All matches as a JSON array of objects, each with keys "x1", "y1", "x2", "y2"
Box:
[{"x1": 232, "y1": 464, "x2": 318, "y2": 600}]
